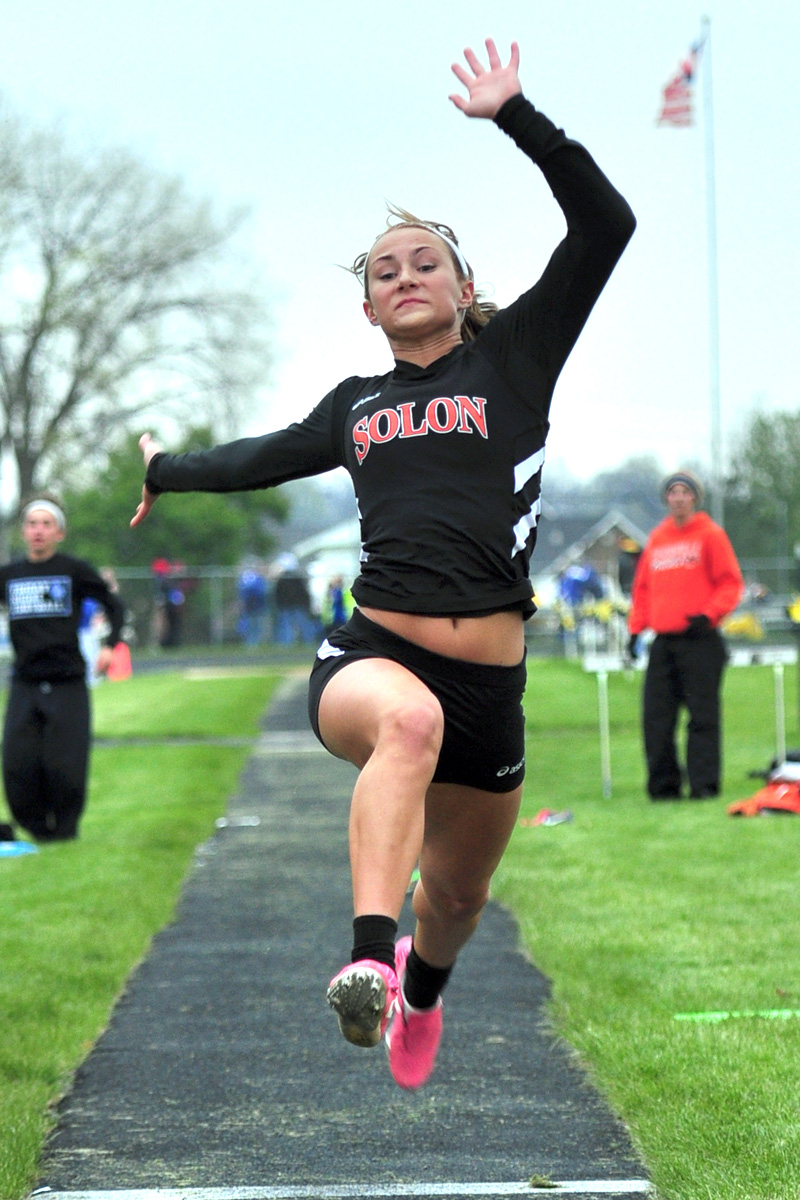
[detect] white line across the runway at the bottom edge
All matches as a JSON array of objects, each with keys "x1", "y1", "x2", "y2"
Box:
[{"x1": 31, "y1": 1180, "x2": 651, "y2": 1200}]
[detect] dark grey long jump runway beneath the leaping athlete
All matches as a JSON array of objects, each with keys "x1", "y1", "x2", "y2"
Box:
[{"x1": 32, "y1": 679, "x2": 649, "y2": 1200}]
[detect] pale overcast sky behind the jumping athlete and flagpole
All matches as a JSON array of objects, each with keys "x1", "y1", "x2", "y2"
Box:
[{"x1": 0, "y1": 0, "x2": 800, "y2": 479}]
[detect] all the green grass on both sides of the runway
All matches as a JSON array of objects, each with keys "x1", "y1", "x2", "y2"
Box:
[{"x1": 0, "y1": 660, "x2": 800, "y2": 1200}]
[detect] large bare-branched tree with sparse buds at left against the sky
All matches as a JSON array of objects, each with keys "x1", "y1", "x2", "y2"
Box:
[{"x1": 0, "y1": 102, "x2": 267, "y2": 511}]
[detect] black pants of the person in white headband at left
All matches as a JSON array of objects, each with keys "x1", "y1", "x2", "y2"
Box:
[{"x1": 2, "y1": 679, "x2": 90, "y2": 841}]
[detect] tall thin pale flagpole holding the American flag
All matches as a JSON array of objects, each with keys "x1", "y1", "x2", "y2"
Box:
[{"x1": 700, "y1": 17, "x2": 724, "y2": 524}]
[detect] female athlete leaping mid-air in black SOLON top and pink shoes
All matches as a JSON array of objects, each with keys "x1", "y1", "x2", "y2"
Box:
[{"x1": 131, "y1": 40, "x2": 634, "y2": 1088}]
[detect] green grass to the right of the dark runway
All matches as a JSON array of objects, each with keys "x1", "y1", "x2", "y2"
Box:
[{"x1": 494, "y1": 661, "x2": 800, "y2": 1200}]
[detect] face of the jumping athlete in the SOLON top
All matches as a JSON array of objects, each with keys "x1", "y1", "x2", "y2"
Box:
[{"x1": 363, "y1": 226, "x2": 474, "y2": 344}]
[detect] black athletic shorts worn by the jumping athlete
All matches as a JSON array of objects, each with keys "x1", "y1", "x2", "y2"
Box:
[{"x1": 308, "y1": 610, "x2": 525, "y2": 792}]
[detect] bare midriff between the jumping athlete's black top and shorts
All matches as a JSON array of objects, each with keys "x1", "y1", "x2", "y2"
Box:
[{"x1": 361, "y1": 608, "x2": 525, "y2": 667}]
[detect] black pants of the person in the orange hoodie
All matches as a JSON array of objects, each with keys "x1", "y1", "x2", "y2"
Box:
[{"x1": 644, "y1": 630, "x2": 728, "y2": 799}]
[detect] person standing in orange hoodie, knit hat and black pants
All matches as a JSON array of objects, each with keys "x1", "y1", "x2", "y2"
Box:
[{"x1": 628, "y1": 470, "x2": 742, "y2": 800}]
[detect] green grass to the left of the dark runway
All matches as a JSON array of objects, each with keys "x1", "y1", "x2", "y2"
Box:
[{"x1": 0, "y1": 672, "x2": 278, "y2": 1200}]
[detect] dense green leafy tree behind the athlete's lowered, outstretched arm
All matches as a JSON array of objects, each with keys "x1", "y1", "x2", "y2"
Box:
[{"x1": 64, "y1": 428, "x2": 288, "y2": 566}]
